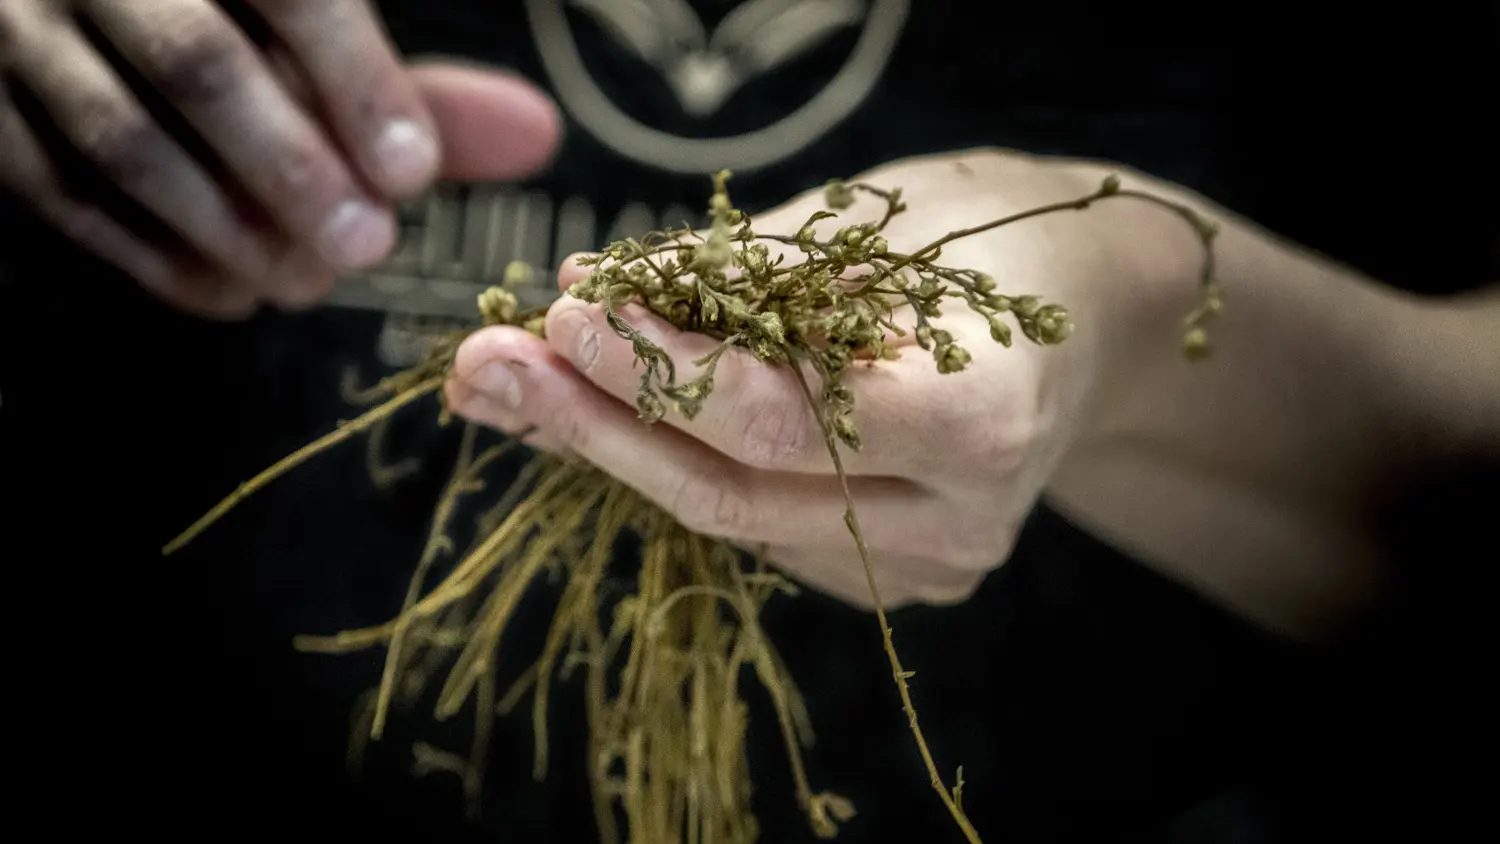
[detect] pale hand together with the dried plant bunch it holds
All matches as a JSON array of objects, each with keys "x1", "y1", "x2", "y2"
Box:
[{"x1": 165, "y1": 148, "x2": 1218, "y2": 844}]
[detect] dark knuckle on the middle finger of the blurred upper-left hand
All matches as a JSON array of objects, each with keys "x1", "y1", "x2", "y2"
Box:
[{"x1": 143, "y1": 16, "x2": 245, "y2": 103}]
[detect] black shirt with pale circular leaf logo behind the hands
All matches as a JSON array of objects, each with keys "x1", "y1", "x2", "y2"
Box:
[{"x1": 0, "y1": 0, "x2": 1500, "y2": 843}]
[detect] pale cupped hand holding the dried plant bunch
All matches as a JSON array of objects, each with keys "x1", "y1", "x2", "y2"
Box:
[{"x1": 447, "y1": 151, "x2": 1164, "y2": 606}]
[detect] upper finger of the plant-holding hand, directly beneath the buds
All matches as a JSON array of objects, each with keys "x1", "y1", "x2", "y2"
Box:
[{"x1": 548, "y1": 250, "x2": 1050, "y2": 490}]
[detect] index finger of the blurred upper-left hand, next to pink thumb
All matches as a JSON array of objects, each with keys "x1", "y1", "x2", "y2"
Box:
[{"x1": 251, "y1": 0, "x2": 441, "y2": 196}]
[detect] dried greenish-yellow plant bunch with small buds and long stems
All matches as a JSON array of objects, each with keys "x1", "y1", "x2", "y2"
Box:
[{"x1": 165, "y1": 172, "x2": 1220, "y2": 844}]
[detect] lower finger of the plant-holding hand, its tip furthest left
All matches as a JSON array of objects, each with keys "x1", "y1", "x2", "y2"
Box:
[{"x1": 449, "y1": 328, "x2": 972, "y2": 555}]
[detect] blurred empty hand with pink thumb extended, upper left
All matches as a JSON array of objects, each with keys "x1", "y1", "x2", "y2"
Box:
[{"x1": 0, "y1": 0, "x2": 560, "y2": 318}]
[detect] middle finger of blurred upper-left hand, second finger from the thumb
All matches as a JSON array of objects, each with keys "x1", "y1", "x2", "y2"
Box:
[{"x1": 86, "y1": 0, "x2": 396, "y2": 287}]
